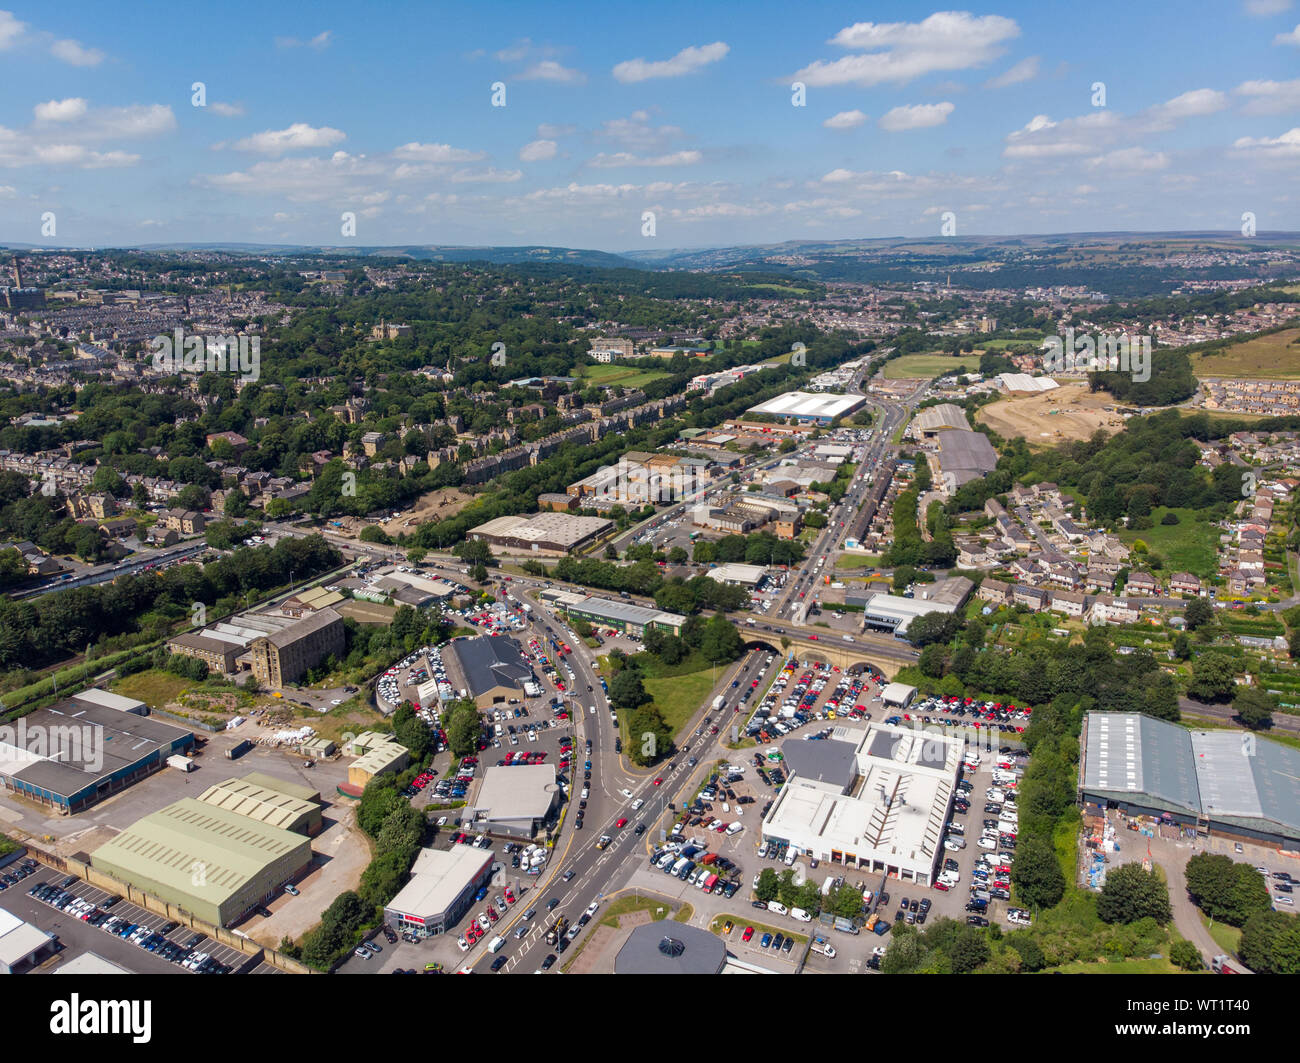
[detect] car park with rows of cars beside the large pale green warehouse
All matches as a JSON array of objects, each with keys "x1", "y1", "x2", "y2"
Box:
[{"x1": 20, "y1": 868, "x2": 250, "y2": 975}]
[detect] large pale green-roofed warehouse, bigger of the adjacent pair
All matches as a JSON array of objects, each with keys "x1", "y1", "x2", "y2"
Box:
[{"x1": 91, "y1": 786, "x2": 312, "y2": 927}]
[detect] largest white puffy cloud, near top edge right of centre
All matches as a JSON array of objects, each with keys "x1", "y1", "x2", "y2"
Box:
[{"x1": 793, "y1": 12, "x2": 1021, "y2": 86}]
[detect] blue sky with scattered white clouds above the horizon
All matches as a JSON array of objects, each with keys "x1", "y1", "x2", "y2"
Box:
[{"x1": 0, "y1": 0, "x2": 1300, "y2": 251}]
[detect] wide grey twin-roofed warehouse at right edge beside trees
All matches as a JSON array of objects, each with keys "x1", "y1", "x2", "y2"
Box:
[{"x1": 1079, "y1": 712, "x2": 1300, "y2": 851}]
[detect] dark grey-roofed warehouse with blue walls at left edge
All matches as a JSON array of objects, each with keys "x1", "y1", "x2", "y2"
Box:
[{"x1": 0, "y1": 690, "x2": 194, "y2": 815}]
